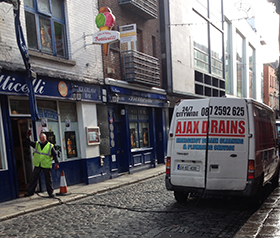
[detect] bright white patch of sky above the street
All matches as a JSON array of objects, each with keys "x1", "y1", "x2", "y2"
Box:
[{"x1": 238, "y1": 0, "x2": 279, "y2": 63}]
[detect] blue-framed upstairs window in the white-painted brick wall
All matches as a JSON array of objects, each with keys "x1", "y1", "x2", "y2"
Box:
[{"x1": 24, "y1": 0, "x2": 67, "y2": 58}]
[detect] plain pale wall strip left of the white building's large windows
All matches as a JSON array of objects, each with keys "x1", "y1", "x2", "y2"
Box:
[{"x1": 163, "y1": 0, "x2": 194, "y2": 93}]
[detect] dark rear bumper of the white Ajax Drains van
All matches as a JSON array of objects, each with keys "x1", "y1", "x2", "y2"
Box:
[{"x1": 165, "y1": 175, "x2": 262, "y2": 197}]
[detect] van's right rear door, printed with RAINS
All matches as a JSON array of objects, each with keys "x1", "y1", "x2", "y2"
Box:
[{"x1": 206, "y1": 98, "x2": 248, "y2": 190}]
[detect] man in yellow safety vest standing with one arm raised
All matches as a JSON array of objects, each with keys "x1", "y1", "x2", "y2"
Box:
[{"x1": 24, "y1": 130, "x2": 59, "y2": 198}]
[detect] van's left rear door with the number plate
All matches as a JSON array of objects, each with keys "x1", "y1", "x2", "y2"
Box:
[{"x1": 170, "y1": 98, "x2": 209, "y2": 188}]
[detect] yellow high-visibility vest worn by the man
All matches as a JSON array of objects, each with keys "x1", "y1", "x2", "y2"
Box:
[{"x1": 33, "y1": 141, "x2": 53, "y2": 169}]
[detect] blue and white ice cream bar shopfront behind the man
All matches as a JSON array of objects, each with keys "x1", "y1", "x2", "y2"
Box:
[{"x1": 0, "y1": 70, "x2": 102, "y2": 202}]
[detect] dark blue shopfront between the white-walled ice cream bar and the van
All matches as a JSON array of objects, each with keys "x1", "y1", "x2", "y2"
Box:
[{"x1": 105, "y1": 79, "x2": 167, "y2": 176}]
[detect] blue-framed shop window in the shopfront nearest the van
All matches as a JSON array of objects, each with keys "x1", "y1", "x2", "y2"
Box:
[{"x1": 128, "y1": 108, "x2": 150, "y2": 149}]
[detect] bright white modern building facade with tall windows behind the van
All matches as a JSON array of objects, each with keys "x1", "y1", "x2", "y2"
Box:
[{"x1": 161, "y1": 0, "x2": 262, "y2": 107}]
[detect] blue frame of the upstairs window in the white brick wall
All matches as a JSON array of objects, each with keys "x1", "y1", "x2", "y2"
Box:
[{"x1": 24, "y1": 0, "x2": 69, "y2": 59}]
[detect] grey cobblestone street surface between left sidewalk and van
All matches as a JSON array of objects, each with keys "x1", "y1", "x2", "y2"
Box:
[{"x1": 0, "y1": 175, "x2": 262, "y2": 238}]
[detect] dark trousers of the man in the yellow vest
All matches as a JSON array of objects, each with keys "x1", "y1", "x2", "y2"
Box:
[{"x1": 28, "y1": 167, "x2": 53, "y2": 195}]
